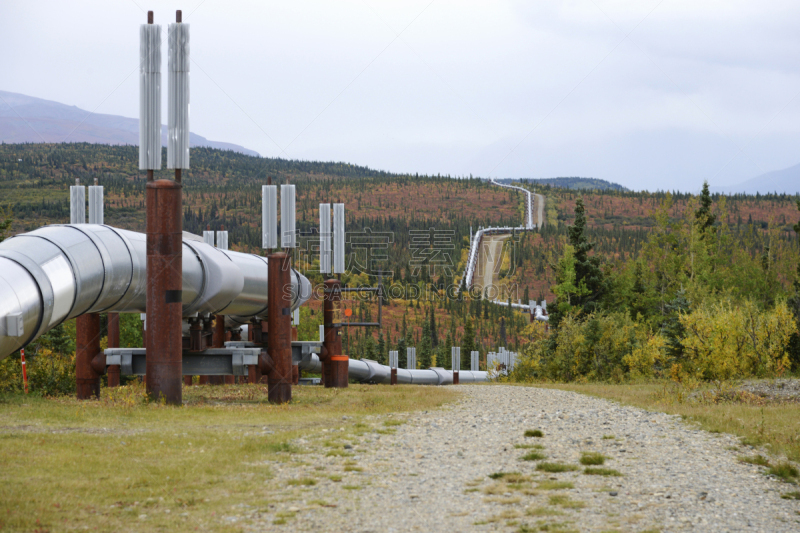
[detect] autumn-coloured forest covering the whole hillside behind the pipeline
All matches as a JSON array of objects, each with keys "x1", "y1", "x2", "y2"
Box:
[{"x1": 0, "y1": 143, "x2": 800, "y2": 392}]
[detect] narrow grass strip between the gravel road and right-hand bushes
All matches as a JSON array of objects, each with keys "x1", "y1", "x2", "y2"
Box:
[{"x1": 537, "y1": 381, "x2": 800, "y2": 462}]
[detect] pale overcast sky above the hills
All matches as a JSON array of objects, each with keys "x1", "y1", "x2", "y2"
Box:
[{"x1": 0, "y1": 0, "x2": 800, "y2": 190}]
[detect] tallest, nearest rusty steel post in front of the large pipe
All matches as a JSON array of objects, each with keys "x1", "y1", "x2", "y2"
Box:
[{"x1": 146, "y1": 169, "x2": 183, "y2": 405}]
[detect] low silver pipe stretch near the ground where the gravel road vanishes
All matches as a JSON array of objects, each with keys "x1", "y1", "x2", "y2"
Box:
[{"x1": 299, "y1": 354, "x2": 489, "y2": 385}]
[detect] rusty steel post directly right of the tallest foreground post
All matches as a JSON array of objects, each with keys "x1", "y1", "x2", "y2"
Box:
[{"x1": 267, "y1": 252, "x2": 292, "y2": 403}]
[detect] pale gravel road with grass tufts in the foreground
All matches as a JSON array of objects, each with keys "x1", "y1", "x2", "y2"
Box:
[{"x1": 242, "y1": 385, "x2": 800, "y2": 533}]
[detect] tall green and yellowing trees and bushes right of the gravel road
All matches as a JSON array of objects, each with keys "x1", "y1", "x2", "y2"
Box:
[{"x1": 513, "y1": 183, "x2": 800, "y2": 390}]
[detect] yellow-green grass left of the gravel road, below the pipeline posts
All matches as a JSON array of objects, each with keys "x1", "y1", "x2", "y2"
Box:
[{"x1": 0, "y1": 384, "x2": 457, "y2": 532}]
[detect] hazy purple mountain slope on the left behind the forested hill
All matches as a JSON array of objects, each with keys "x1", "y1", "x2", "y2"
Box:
[{"x1": 0, "y1": 91, "x2": 258, "y2": 156}]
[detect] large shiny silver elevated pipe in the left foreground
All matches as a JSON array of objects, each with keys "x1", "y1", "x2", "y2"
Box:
[{"x1": 0, "y1": 224, "x2": 311, "y2": 360}]
